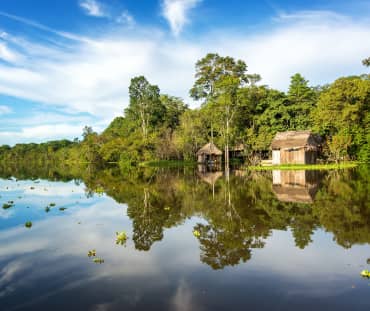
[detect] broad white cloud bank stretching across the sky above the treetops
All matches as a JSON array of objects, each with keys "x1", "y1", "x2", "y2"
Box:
[{"x1": 0, "y1": 12, "x2": 370, "y2": 145}]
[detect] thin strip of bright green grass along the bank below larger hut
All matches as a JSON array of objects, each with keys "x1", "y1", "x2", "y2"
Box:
[{"x1": 246, "y1": 162, "x2": 358, "y2": 171}]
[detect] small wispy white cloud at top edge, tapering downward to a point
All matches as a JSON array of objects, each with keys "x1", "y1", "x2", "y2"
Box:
[{"x1": 162, "y1": 0, "x2": 202, "y2": 36}]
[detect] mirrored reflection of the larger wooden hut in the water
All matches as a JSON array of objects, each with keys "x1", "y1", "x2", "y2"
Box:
[{"x1": 272, "y1": 170, "x2": 320, "y2": 203}]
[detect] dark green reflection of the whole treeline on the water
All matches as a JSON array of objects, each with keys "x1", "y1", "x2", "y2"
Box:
[{"x1": 0, "y1": 165, "x2": 370, "y2": 269}]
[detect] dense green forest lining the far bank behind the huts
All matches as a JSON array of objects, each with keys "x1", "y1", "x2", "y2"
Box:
[{"x1": 0, "y1": 54, "x2": 370, "y2": 166}]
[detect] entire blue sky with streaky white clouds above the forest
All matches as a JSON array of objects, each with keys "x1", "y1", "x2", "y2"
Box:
[{"x1": 0, "y1": 0, "x2": 370, "y2": 145}]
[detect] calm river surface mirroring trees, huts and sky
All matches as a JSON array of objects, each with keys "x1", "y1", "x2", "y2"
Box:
[{"x1": 0, "y1": 167, "x2": 370, "y2": 310}]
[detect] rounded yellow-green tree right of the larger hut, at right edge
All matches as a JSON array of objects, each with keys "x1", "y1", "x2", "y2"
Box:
[{"x1": 312, "y1": 77, "x2": 370, "y2": 161}]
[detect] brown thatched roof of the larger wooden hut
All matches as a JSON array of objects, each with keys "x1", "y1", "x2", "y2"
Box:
[{"x1": 271, "y1": 131, "x2": 321, "y2": 150}]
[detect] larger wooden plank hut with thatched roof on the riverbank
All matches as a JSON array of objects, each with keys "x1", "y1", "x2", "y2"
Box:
[{"x1": 271, "y1": 131, "x2": 321, "y2": 164}]
